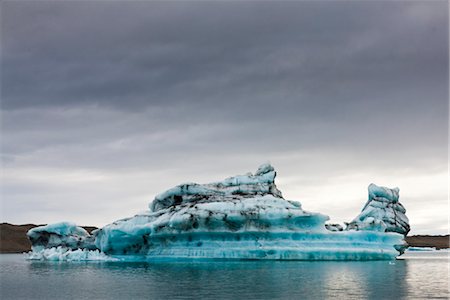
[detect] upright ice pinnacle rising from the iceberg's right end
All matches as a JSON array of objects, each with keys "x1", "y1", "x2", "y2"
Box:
[{"x1": 347, "y1": 183, "x2": 410, "y2": 236}]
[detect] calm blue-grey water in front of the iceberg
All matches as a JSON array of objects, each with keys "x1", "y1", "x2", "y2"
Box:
[{"x1": 0, "y1": 251, "x2": 449, "y2": 300}]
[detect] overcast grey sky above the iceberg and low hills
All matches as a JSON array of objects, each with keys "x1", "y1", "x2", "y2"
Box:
[{"x1": 0, "y1": 1, "x2": 449, "y2": 234}]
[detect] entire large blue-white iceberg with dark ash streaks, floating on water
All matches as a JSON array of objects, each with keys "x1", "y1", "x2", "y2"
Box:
[{"x1": 28, "y1": 164, "x2": 410, "y2": 260}]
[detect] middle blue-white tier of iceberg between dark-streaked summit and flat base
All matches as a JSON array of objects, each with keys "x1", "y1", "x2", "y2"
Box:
[{"x1": 96, "y1": 195, "x2": 328, "y2": 254}]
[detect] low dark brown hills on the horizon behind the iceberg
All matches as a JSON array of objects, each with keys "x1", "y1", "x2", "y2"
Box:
[{"x1": 0, "y1": 223, "x2": 450, "y2": 253}]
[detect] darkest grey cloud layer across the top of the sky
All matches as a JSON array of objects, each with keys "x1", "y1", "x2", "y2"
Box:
[{"x1": 3, "y1": 2, "x2": 448, "y2": 108}]
